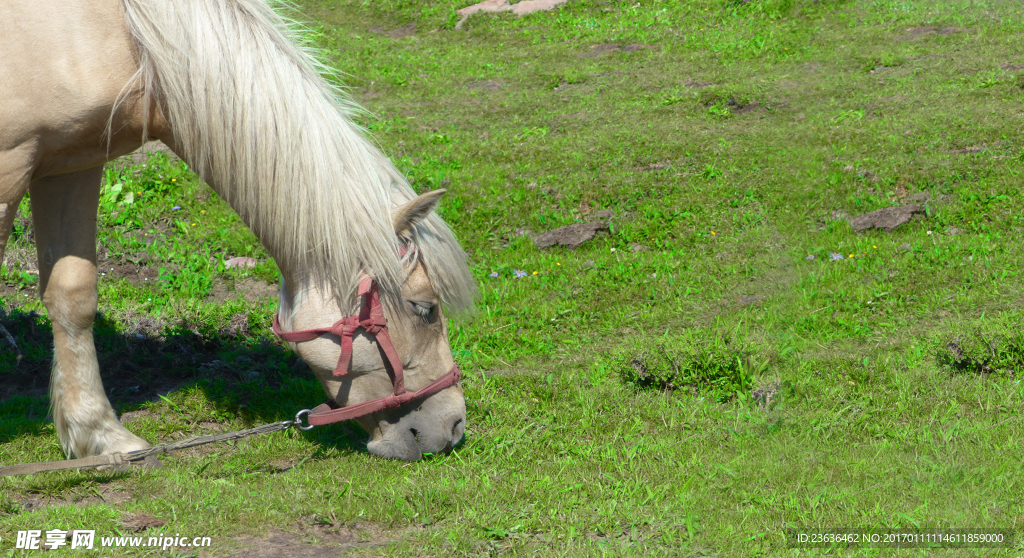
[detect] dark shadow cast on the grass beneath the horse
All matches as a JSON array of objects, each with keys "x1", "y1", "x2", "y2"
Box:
[{"x1": 0, "y1": 309, "x2": 368, "y2": 454}]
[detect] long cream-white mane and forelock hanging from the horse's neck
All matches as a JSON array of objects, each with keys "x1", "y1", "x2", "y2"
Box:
[{"x1": 119, "y1": 0, "x2": 476, "y2": 311}]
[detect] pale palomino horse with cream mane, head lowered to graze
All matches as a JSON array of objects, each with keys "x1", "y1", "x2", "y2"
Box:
[{"x1": 0, "y1": 0, "x2": 475, "y2": 461}]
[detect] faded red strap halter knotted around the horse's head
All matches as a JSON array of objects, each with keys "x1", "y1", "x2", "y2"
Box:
[{"x1": 273, "y1": 276, "x2": 462, "y2": 426}]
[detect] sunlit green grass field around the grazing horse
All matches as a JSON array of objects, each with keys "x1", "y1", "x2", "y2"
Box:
[{"x1": 0, "y1": 0, "x2": 1024, "y2": 556}]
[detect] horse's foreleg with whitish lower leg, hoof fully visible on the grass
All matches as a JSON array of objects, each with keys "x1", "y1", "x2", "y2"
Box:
[{"x1": 30, "y1": 167, "x2": 150, "y2": 458}]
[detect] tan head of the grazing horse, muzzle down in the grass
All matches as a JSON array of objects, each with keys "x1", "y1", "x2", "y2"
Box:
[{"x1": 279, "y1": 190, "x2": 466, "y2": 461}]
